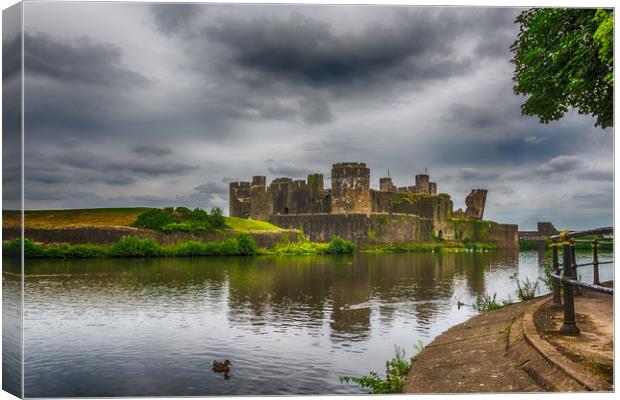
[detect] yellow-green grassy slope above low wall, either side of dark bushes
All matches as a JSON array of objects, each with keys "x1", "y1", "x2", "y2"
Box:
[{"x1": 2, "y1": 208, "x2": 281, "y2": 232}]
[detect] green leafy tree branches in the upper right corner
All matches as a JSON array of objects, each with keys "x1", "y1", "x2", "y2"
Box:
[{"x1": 510, "y1": 8, "x2": 614, "y2": 128}]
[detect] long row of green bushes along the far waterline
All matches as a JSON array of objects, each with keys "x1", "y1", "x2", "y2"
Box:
[{"x1": 2, "y1": 233, "x2": 355, "y2": 259}]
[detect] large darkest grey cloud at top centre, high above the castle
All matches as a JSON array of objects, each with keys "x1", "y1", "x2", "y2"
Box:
[{"x1": 205, "y1": 11, "x2": 464, "y2": 86}]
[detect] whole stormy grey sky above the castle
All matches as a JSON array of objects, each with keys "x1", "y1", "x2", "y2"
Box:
[{"x1": 3, "y1": 2, "x2": 613, "y2": 229}]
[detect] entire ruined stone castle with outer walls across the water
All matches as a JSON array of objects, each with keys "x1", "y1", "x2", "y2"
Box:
[{"x1": 229, "y1": 162, "x2": 517, "y2": 247}]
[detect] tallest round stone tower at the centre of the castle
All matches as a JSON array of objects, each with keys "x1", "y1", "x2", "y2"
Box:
[{"x1": 331, "y1": 162, "x2": 371, "y2": 214}]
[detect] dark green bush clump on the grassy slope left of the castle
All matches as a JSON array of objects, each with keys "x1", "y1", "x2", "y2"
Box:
[{"x1": 133, "y1": 207, "x2": 226, "y2": 233}]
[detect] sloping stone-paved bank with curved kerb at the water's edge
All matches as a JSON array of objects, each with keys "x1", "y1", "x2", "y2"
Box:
[{"x1": 403, "y1": 290, "x2": 613, "y2": 393}]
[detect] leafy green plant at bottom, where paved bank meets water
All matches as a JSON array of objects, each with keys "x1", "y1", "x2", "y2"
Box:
[{"x1": 339, "y1": 344, "x2": 423, "y2": 394}]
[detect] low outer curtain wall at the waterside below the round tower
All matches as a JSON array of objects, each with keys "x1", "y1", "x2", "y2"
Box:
[{"x1": 271, "y1": 213, "x2": 433, "y2": 245}]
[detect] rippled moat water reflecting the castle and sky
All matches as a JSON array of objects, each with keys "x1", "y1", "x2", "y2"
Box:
[{"x1": 3, "y1": 251, "x2": 613, "y2": 397}]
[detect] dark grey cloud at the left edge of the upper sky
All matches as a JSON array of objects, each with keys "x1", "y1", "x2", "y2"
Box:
[{"x1": 24, "y1": 33, "x2": 149, "y2": 89}]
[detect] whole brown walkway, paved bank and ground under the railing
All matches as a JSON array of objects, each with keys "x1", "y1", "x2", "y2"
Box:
[{"x1": 403, "y1": 290, "x2": 613, "y2": 393}]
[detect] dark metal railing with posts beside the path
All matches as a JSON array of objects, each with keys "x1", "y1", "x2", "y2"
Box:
[{"x1": 549, "y1": 227, "x2": 614, "y2": 336}]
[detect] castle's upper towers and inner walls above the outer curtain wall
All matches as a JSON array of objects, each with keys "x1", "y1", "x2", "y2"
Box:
[{"x1": 229, "y1": 162, "x2": 487, "y2": 220}]
